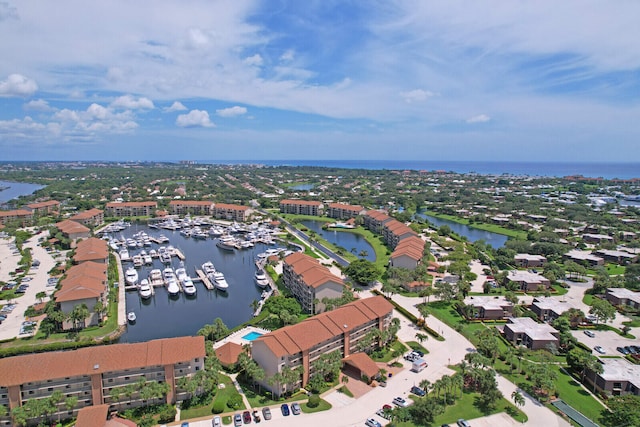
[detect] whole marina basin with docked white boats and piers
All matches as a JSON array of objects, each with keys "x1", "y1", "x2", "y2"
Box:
[{"x1": 104, "y1": 222, "x2": 290, "y2": 342}]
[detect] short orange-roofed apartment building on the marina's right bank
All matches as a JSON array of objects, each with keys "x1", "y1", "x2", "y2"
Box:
[{"x1": 282, "y1": 252, "x2": 344, "y2": 314}]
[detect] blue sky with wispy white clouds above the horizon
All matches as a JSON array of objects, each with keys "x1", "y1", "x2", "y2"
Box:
[{"x1": 0, "y1": 0, "x2": 640, "y2": 162}]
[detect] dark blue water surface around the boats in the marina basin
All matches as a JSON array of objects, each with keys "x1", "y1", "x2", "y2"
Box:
[{"x1": 115, "y1": 225, "x2": 273, "y2": 342}]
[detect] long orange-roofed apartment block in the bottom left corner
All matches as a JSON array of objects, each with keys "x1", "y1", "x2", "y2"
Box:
[{"x1": 0, "y1": 336, "x2": 206, "y2": 426}]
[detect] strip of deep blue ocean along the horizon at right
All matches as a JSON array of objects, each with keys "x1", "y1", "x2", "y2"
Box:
[{"x1": 199, "y1": 160, "x2": 640, "y2": 179}]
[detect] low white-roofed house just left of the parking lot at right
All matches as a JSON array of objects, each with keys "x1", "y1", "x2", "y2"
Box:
[{"x1": 503, "y1": 317, "x2": 560, "y2": 350}]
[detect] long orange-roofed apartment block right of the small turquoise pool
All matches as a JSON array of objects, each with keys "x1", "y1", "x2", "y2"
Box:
[{"x1": 251, "y1": 296, "x2": 393, "y2": 395}]
